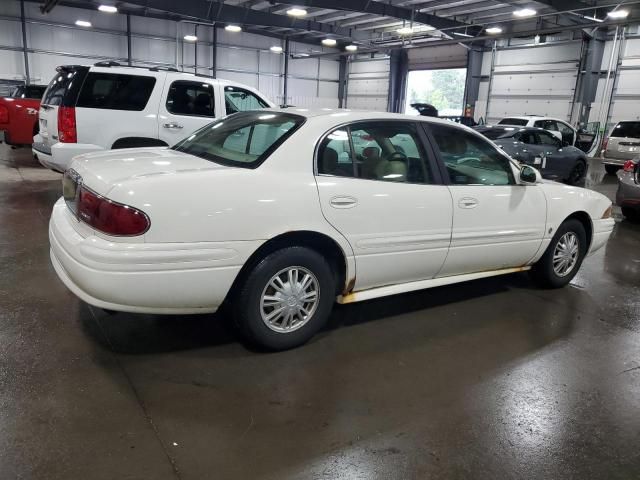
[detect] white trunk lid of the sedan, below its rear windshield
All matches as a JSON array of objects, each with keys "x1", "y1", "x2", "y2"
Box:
[{"x1": 70, "y1": 147, "x2": 226, "y2": 195}]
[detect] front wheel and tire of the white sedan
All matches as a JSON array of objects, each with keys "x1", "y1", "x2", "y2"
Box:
[{"x1": 531, "y1": 218, "x2": 587, "y2": 288}]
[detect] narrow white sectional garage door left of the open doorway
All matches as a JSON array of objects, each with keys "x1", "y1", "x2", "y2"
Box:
[{"x1": 346, "y1": 56, "x2": 389, "y2": 112}]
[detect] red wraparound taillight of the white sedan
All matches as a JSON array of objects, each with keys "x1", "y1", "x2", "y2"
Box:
[{"x1": 77, "y1": 186, "x2": 151, "y2": 236}]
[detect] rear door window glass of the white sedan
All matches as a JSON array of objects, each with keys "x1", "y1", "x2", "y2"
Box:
[{"x1": 317, "y1": 122, "x2": 433, "y2": 183}]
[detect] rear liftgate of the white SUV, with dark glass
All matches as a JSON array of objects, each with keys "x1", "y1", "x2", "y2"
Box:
[{"x1": 34, "y1": 67, "x2": 89, "y2": 154}]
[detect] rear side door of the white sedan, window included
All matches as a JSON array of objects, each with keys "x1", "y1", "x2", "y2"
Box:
[{"x1": 316, "y1": 121, "x2": 453, "y2": 290}]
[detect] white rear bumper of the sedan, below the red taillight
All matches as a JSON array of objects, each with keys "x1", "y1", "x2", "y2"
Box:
[{"x1": 49, "y1": 199, "x2": 252, "y2": 314}]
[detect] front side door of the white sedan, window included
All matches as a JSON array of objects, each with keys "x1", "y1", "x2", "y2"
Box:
[{"x1": 428, "y1": 124, "x2": 547, "y2": 276}]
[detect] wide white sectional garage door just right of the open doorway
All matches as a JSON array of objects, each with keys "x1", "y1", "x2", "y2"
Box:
[{"x1": 475, "y1": 40, "x2": 582, "y2": 124}]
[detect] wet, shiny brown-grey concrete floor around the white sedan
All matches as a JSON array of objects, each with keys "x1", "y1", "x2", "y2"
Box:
[{"x1": 0, "y1": 145, "x2": 640, "y2": 480}]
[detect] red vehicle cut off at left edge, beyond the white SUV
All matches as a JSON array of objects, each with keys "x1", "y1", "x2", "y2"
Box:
[{"x1": 0, "y1": 85, "x2": 47, "y2": 145}]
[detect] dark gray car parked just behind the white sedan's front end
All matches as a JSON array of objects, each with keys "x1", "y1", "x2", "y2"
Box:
[{"x1": 475, "y1": 125, "x2": 587, "y2": 185}]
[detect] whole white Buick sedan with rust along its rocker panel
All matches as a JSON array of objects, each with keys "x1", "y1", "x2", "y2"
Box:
[{"x1": 49, "y1": 109, "x2": 614, "y2": 349}]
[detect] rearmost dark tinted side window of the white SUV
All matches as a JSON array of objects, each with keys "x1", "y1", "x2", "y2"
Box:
[{"x1": 76, "y1": 72, "x2": 156, "y2": 112}]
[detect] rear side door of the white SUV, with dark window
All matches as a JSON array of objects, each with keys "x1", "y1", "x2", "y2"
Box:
[{"x1": 158, "y1": 76, "x2": 217, "y2": 145}]
